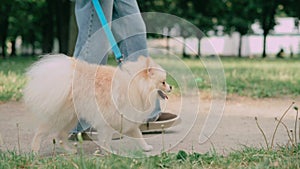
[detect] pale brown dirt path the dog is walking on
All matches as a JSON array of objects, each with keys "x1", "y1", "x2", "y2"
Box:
[{"x1": 0, "y1": 96, "x2": 300, "y2": 156}]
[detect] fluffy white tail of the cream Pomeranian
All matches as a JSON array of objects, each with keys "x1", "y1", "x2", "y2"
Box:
[{"x1": 24, "y1": 54, "x2": 73, "y2": 119}]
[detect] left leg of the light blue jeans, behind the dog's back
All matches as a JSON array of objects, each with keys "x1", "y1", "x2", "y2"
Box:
[{"x1": 71, "y1": 0, "x2": 113, "y2": 133}]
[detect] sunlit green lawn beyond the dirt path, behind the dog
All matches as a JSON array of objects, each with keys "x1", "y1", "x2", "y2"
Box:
[{"x1": 0, "y1": 57, "x2": 300, "y2": 102}]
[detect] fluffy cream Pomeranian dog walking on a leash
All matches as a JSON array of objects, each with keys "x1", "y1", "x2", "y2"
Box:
[{"x1": 24, "y1": 54, "x2": 171, "y2": 152}]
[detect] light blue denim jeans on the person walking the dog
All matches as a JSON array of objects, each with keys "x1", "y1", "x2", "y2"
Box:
[{"x1": 71, "y1": 0, "x2": 161, "y2": 133}]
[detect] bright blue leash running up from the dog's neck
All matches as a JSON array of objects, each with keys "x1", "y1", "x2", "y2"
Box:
[{"x1": 92, "y1": 0, "x2": 123, "y2": 63}]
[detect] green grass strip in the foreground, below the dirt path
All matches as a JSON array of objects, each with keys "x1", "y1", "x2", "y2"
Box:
[{"x1": 0, "y1": 145, "x2": 300, "y2": 169}]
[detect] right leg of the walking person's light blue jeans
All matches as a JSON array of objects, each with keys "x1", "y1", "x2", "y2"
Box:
[{"x1": 112, "y1": 0, "x2": 161, "y2": 122}]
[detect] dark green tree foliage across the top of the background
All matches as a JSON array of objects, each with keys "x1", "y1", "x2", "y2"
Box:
[{"x1": 0, "y1": 0, "x2": 299, "y2": 55}]
